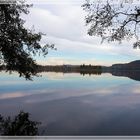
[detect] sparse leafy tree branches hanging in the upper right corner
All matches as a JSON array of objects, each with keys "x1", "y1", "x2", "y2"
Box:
[{"x1": 82, "y1": 0, "x2": 140, "y2": 48}]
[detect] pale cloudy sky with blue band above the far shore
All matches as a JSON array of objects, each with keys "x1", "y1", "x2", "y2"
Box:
[{"x1": 23, "y1": 0, "x2": 140, "y2": 66}]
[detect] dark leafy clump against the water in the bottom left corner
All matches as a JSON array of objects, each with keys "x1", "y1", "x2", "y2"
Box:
[{"x1": 0, "y1": 111, "x2": 40, "y2": 136}]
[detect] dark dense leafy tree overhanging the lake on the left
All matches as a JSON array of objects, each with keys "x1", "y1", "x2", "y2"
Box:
[{"x1": 0, "y1": 1, "x2": 54, "y2": 79}]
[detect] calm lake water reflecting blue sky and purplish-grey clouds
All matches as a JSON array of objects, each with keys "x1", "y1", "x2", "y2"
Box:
[{"x1": 0, "y1": 72, "x2": 140, "y2": 136}]
